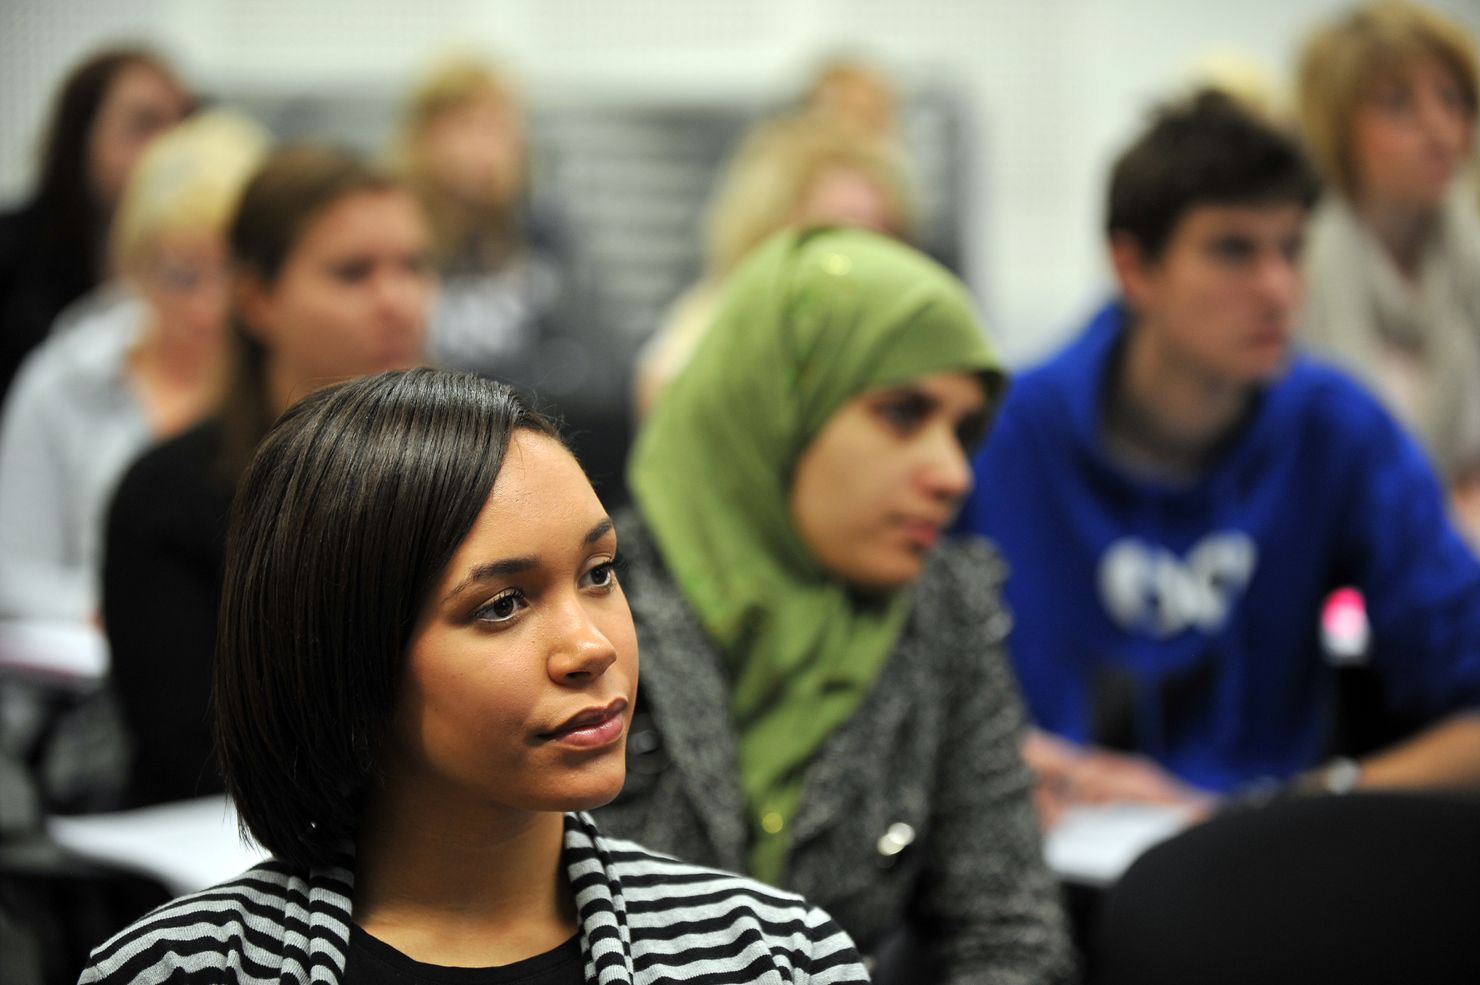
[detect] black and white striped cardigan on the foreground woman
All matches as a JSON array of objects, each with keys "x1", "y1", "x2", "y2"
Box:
[{"x1": 81, "y1": 813, "x2": 869, "y2": 985}]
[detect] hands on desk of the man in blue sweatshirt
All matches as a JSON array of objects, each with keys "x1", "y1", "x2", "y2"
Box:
[{"x1": 1023, "y1": 729, "x2": 1218, "y2": 831}]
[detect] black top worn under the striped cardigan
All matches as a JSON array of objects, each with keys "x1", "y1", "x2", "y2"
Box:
[{"x1": 345, "y1": 924, "x2": 586, "y2": 985}]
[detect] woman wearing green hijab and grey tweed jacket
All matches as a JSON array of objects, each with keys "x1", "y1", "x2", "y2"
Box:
[{"x1": 604, "y1": 229, "x2": 1069, "y2": 982}]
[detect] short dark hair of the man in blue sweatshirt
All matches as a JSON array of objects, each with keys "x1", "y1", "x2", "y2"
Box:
[{"x1": 1106, "y1": 90, "x2": 1319, "y2": 259}]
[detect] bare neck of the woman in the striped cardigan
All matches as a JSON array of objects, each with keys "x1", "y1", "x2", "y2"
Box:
[{"x1": 354, "y1": 790, "x2": 577, "y2": 967}]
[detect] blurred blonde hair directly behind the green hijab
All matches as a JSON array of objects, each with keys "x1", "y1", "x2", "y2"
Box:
[{"x1": 704, "y1": 114, "x2": 916, "y2": 278}]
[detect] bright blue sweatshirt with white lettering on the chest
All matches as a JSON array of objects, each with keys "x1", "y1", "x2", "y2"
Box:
[{"x1": 962, "y1": 305, "x2": 1480, "y2": 790}]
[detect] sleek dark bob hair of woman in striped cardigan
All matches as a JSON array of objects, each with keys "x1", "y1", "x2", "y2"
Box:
[{"x1": 213, "y1": 368, "x2": 558, "y2": 867}]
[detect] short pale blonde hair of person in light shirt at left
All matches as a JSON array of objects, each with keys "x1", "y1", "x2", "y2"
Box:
[{"x1": 111, "y1": 109, "x2": 271, "y2": 272}]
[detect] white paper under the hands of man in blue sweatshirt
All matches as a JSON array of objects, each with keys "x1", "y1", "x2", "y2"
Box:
[{"x1": 1043, "y1": 802, "x2": 1190, "y2": 886}]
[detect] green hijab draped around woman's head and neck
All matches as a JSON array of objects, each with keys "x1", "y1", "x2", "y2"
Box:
[{"x1": 628, "y1": 229, "x2": 1000, "y2": 883}]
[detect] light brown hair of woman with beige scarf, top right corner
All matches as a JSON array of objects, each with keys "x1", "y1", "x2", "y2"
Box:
[{"x1": 1298, "y1": 0, "x2": 1477, "y2": 197}]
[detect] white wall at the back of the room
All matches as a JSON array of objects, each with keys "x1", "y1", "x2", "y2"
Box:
[{"x1": 0, "y1": 0, "x2": 1480, "y2": 361}]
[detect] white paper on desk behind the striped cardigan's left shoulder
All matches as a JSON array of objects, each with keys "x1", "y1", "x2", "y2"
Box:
[{"x1": 46, "y1": 796, "x2": 268, "y2": 893}]
